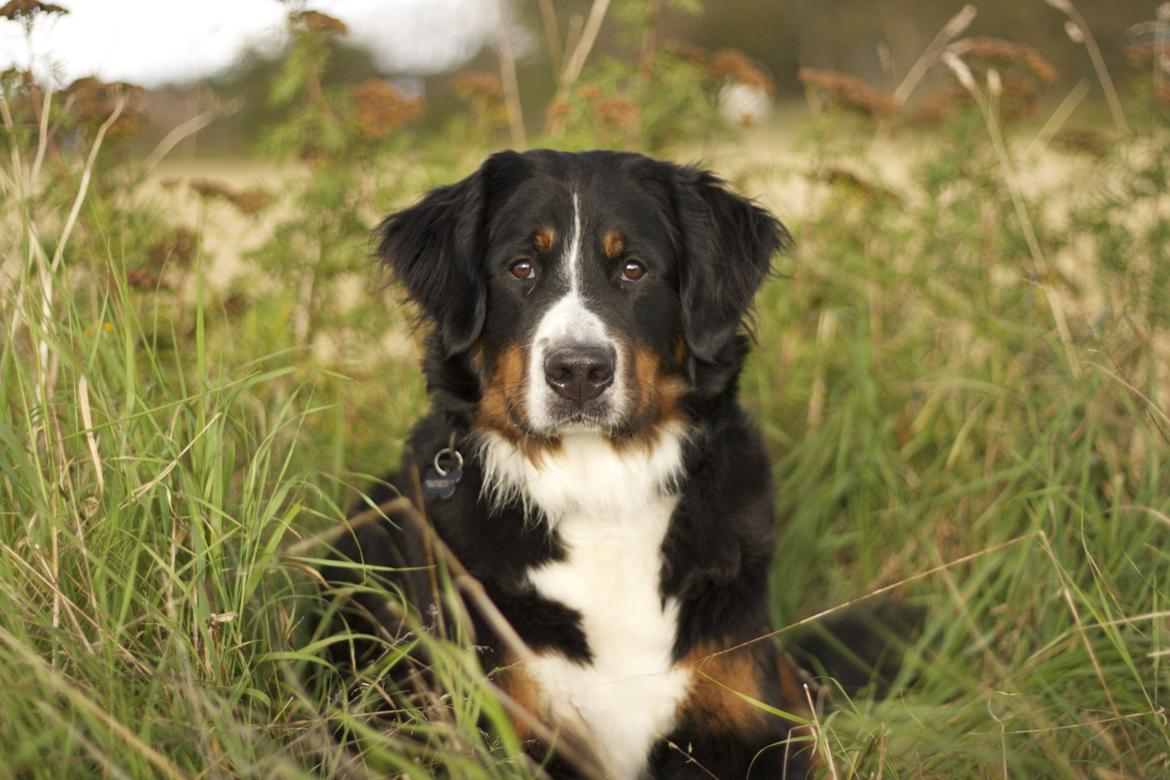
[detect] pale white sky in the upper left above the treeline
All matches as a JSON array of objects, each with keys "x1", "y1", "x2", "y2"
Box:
[{"x1": 0, "y1": 0, "x2": 510, "y2": 87}]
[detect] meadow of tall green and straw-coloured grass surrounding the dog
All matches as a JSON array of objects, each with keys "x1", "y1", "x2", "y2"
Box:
[{"x1": 0, "y1": 2, "x2": 1170, "y2": 780}]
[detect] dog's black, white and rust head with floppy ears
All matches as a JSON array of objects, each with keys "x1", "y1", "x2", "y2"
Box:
[{"x1": 379, "y1": 151, "x2": 789, "y2": 449}]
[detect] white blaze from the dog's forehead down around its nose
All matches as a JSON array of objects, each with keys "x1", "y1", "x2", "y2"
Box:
[{"x1": 525, "y1": 192, "x2": 625, "y2": 432}]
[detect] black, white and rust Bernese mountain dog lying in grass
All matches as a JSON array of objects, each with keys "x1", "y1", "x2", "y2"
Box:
[{"x1": 324, "y1": 151, "x2": 810, "y2": 779}]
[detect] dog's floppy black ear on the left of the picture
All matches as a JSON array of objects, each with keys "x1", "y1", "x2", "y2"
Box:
[{"x1": 376, "y1": 152, "x2": 524, "y2": 354}]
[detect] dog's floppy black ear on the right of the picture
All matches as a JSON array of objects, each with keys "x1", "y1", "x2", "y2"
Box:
[{"x1": 675, "y1": 168, "x2": 792, "y2": 363}]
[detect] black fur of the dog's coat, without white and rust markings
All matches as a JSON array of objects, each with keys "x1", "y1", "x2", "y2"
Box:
[{"x1": 324, "y1": 151, "x2": 847, "y2": 778}]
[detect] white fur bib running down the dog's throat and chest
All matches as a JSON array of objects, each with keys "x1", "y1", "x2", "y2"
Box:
[{"x1": 475, "y1": 430, "x2": 691, "y2": 780}]
